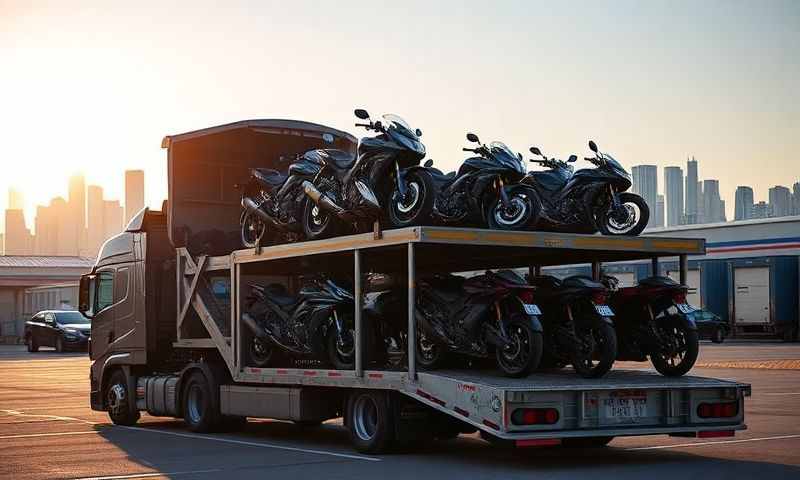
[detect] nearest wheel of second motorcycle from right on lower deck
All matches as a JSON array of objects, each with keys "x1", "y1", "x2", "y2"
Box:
[{"x1": 572, "y1": 322, "x2": 617, "y2": 378}]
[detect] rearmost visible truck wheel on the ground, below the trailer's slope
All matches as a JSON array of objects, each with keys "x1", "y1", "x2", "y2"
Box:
[{"x1": 347, "y1": 390, "x2": 394, "y2": 453}]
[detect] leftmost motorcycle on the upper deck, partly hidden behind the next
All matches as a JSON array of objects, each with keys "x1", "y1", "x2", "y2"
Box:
[{"x1": 239, "y1": 150, "x2": 322, "y2": 248}]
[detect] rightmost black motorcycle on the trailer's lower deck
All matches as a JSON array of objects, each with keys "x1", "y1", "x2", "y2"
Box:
[{"x1": 603, "y1": 276, "x2": 700, "y2": 377}]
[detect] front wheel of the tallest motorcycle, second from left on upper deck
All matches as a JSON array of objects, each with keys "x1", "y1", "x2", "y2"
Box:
[{"x1": 389, "y1": 170, "x2": 435, "y2": 228}]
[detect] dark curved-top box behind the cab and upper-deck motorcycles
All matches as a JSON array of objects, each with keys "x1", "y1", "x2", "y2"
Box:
[{"x1": 162, "y1": 120, "x2": 357, "y2": 255}]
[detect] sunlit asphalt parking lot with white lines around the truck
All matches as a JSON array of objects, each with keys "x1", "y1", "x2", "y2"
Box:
[{"x1": 0, "y1": 342, "x2": 800, "y2": 480}]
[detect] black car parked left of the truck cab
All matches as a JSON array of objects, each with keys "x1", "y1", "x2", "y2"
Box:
[{"x1": 25, "y1": 310, "x2": 92, "y2": 352}]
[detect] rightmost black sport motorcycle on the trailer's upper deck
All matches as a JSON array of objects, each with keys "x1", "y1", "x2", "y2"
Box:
[{"x1": 521, "y1": 141, "x2": 650, "y2": 236}]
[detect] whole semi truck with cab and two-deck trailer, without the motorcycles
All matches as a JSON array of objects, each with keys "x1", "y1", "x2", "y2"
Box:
[{"x1": 79, "y1": 120, "x2": 750, "y2": 454}]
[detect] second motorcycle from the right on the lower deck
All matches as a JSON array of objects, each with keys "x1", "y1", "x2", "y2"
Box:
[{"x1": 530, "y1": 275, "x2": 617, "y2": 378}]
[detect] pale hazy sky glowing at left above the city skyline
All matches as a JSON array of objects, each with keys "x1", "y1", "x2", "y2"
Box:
[{"x1": 0, "y1": 0, "x2": 800, "y2": 232}]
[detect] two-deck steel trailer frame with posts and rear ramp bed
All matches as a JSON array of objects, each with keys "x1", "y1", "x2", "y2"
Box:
[{"x1": 175, "y1": 227, "x2": 750, "y2": 440}]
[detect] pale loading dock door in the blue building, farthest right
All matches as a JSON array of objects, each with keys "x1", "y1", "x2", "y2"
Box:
[{"x1": 733, "y1": 267, "x2": 770, "y2": 323}]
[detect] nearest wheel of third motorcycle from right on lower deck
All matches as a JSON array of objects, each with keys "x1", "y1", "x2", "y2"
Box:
[{"x1": 495, "y1": 318, "x2": 543, "y2": 378}]
